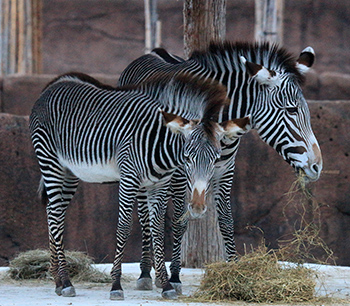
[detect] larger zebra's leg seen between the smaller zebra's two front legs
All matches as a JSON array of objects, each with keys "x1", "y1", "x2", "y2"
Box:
[{"x1": 136, "y1": 191, "x2": 153, "y2": 290}]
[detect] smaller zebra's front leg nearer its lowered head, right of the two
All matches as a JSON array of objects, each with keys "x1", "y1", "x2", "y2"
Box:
[{"x1": 148, "y1": 186, "x2": 177, "y2": 299}]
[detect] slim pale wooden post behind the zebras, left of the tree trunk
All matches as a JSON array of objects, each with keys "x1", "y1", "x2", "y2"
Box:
[{"x1": 145, "y1": 0, "x2": 161, "y2": 53}]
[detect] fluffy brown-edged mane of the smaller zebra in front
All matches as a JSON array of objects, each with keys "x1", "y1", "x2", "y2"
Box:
[{"x1": 120, "y1": 73, "x2": 229, "y2": 140}]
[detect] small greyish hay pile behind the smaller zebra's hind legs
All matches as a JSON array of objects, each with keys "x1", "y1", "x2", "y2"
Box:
[{"x1": 9, "y1": 250, "x2": 111, "y2": 283}]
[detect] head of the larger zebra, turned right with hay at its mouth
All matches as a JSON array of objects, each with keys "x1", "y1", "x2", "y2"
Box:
[{"x1": 241, "y1": 47, "x2": 322, "y2": 182}]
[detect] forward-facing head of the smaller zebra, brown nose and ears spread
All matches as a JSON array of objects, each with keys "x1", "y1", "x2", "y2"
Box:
[{"x1": 162, "y1": 112, "x2": 250, "y2": 218}]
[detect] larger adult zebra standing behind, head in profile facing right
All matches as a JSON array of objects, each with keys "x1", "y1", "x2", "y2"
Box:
[{"x1": 119, "y1": 42, "x2": 322, "y2": 291}]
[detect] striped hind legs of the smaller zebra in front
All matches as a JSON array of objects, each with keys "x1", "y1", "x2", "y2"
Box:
[{"x1": 43, "y1": 170, "x2": 79, "y2": 297}]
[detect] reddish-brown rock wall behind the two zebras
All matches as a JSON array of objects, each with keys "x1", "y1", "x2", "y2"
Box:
[{"x1": 0, "y1": 0, "x2": 350, "y2": 266}]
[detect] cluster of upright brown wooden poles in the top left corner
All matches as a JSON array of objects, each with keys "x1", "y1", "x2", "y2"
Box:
[{"x1": 0, "y1": 0, "x2": 42, "y2": 75}]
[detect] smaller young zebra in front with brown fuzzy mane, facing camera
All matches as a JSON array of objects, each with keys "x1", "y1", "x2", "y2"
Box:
[{"x1": 29, "y1": 73, "x2": 249, "y2": 299}]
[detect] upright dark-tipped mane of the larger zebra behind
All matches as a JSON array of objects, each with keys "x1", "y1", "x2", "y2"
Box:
[{"x1": 190, "y1": 41, "x2": 304, "y2": 83}]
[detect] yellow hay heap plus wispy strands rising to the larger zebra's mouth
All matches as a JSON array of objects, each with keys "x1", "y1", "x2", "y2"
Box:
[{"x1": 194, "y1": 173, "x2": 335, "y2": 303}]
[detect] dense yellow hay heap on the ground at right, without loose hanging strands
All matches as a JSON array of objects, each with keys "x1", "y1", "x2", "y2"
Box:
[{"x1": 194, "y1": 248, "x2": 316, "y2": 303}]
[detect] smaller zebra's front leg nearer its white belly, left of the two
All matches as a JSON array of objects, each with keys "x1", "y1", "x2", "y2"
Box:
[{"x1": 110, "y1": 177, "x2": 139, "y2": 300}]
